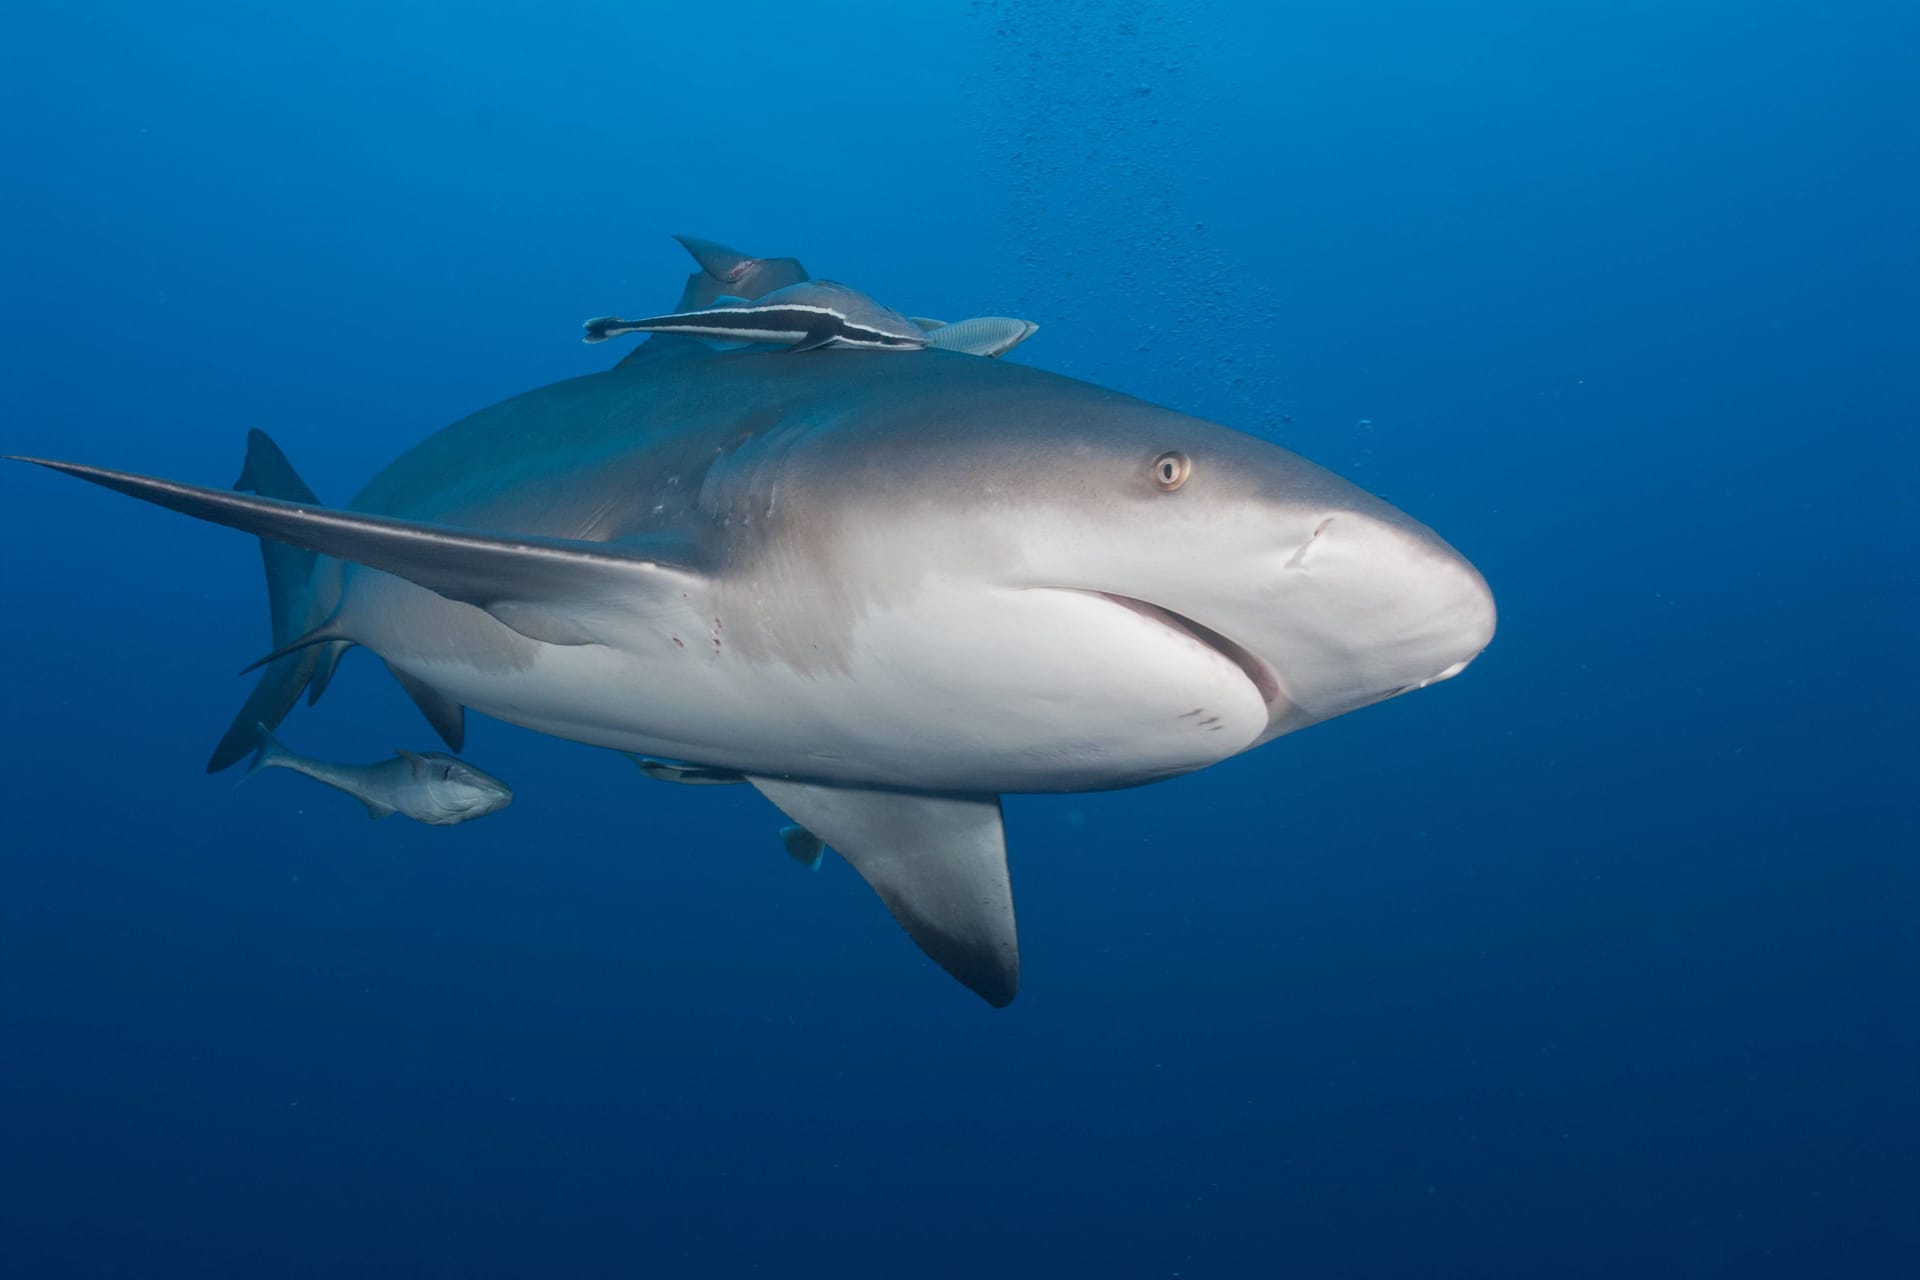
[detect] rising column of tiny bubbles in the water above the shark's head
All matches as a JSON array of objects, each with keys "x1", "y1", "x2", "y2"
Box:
[{"x1": 970, "y1": 0, "x2": 1283, "y2": 436}]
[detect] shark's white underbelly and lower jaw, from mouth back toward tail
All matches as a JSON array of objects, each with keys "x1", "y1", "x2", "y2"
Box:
[{"x1": 346, "y1": 574, "x2": 1267, "y2": 791}]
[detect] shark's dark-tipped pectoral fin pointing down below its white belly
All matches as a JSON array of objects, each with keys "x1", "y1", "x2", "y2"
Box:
[{"x1": 747, "y1": 777, "x2": 1020, "y2": 1007}]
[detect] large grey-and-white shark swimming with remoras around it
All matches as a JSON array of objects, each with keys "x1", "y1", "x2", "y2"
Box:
[{"x1": 7, "y1": 242, "x2": 1494, "y2": 1006}]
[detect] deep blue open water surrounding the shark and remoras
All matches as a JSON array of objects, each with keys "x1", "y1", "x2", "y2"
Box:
[{"x1": 0, "y1": 0, "x2": 1920, "y2": 1280}]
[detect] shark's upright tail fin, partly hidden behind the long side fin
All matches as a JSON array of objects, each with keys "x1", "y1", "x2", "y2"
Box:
[{"x1": 207, "y1": 430, "x2": 346, "y2": 773}]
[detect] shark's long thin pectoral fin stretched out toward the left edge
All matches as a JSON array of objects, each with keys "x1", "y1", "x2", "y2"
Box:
[{"x1": 15, "y1": 459, "x2": 705, "y2": 644}]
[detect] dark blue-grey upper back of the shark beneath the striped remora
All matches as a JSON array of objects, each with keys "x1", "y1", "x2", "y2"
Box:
[{"x1": 351, "y1": 345, "x2": 1164, "y2": 541}]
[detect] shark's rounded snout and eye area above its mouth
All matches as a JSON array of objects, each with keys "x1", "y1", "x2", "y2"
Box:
[{"x1": 1058, "y1": 411, "x2": 1496, "y2": 741}]
